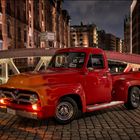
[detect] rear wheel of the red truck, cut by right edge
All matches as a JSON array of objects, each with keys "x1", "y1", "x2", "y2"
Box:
[{"x1": 124, "y1": 87, "x2": 140, "y2": 109}]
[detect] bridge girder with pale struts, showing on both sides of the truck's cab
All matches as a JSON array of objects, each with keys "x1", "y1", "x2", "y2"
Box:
[{"x1": 0, "y1": 48, "x2": 140, "y2": 83}]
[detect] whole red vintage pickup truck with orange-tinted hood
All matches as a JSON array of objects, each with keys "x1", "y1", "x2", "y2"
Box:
[{"x1": 0, "y1": 48, "x2": 140, "y2": 124}]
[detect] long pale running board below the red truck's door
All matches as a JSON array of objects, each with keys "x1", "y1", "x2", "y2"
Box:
[{"x1": 87, "y1": 101, "x2": 124, "y2": 112}]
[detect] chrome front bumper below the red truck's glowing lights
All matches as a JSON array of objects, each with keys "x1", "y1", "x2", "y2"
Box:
[{"x1": 0, "y1": 107, "x2": 37, "y2": 119}]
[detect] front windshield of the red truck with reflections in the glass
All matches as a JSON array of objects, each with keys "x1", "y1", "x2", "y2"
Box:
[{"x1": 48, "y1": 52, "x2": 86, "y2": 68}]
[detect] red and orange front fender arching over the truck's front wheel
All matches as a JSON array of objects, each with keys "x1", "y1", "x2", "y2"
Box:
[{"x1": 38, "y1": 83, "x2": 86, "y2": 112}]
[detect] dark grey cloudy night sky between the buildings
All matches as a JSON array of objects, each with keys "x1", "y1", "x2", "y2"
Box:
[{"x1": 63, "y1": 0, "x2": 132, "y2": 38}]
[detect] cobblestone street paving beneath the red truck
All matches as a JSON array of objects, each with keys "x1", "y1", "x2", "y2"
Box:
[{"x1": 0, "y1": 106, "x2": 140, "y2": 140}]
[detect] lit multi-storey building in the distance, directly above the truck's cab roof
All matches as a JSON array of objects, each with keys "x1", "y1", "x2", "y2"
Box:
[{"x1": 70, "y1": 23, "x2": 98, "y2": 47}]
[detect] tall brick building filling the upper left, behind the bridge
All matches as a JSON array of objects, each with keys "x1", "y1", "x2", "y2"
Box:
[{"x1": 0, "y1": 0, "x2": 70, "y2": 50}]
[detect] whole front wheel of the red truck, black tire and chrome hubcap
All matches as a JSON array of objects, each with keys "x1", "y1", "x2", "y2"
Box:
[{"x1": 55, "y1": 97, "x2": 78, "y2": 124}]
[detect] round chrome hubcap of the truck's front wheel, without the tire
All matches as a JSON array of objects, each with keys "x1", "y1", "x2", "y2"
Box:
[{"x1": 56, "y1": 102, "x2": 73, "y2": 121}]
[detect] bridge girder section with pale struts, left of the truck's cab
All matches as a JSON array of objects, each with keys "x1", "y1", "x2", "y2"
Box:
[{"x1": 0, "y1": 48, "x2": 57, "y2": 84}]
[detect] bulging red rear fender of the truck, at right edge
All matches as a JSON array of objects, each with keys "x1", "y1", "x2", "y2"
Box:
[{"x1": 112, "y1": 79, "x2": 140, "y2": 102}]
